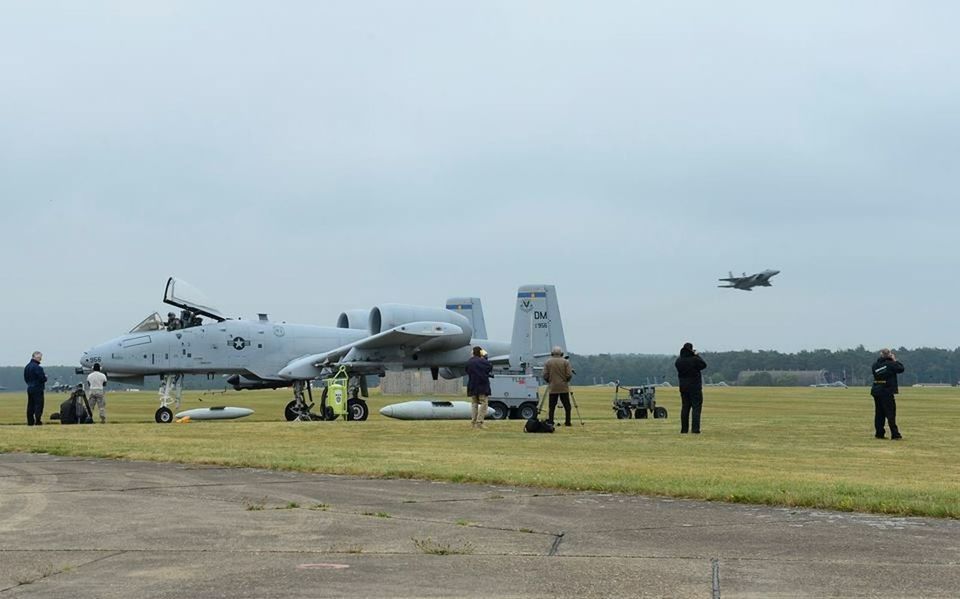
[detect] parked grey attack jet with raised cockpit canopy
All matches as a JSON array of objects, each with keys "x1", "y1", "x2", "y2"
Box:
[{"x1": 77, "y1": 277, "x2": 566, "y2": 423}]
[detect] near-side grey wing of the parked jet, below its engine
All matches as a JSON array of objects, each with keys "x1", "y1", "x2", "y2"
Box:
[{"x1": 279, "y1": 322, "x2": 463, "y2": 380}]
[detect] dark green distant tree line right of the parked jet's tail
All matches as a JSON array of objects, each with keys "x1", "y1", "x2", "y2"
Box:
[{"x1": 570, "y1": 345, "x2": 960, "y2": 386}]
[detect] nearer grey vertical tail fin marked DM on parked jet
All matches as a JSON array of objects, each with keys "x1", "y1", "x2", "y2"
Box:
[{"x1": 510, "y1": 285, "x2": 567, "y2": 370}]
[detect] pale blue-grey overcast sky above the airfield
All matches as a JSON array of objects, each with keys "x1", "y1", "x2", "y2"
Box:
[{"x1": 0, "y1": 0, "x2": 960, "y2": 365}]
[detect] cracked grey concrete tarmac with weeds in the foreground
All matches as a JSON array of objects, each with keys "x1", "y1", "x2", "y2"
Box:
[{"x1": 0, "y1": 454, "x2": 960, "y2": 599}]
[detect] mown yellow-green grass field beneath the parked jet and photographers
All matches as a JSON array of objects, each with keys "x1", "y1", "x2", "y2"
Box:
[{"x1": 0, "y1": 387, "x2": 960, "y2": 518}]
